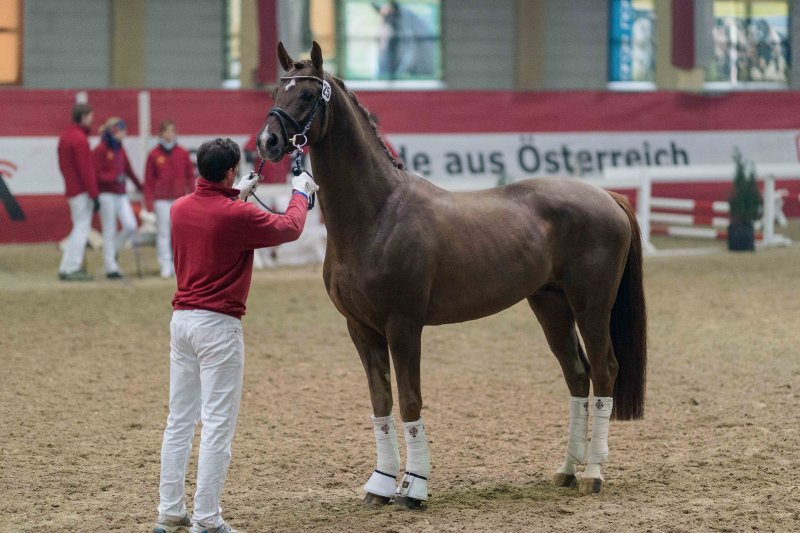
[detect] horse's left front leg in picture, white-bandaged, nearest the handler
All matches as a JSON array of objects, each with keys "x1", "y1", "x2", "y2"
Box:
[{"x1": 347, "y1": 321, "x2": 400, "y2": 505}]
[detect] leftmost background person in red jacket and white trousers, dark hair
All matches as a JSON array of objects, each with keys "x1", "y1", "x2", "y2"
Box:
[{"x1": 58, "y1": 104, "x2": 98, "y2": 281}]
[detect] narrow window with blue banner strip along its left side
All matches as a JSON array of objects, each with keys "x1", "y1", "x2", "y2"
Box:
[{"x1": 608, "y1": 0, "x2": 656, "y2": 84}]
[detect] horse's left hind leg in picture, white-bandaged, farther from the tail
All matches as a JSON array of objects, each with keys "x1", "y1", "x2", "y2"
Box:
[{"x1": 528, "y1": 287, "x2": 589, "y2": 487}]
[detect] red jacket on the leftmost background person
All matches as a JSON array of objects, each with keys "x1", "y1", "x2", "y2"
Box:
[{"x1": 58, "y1": 123, "x2": 97, "y2": 198}]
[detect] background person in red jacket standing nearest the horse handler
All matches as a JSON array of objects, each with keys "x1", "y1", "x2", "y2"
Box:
[{"x1": 144, "y1": 120, "x2": 195, "y2": 278}]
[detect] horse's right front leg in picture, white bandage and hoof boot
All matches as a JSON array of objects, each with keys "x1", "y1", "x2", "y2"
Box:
[{"x1": 386, "y1": 320, "x2": 431, "y2": 509}]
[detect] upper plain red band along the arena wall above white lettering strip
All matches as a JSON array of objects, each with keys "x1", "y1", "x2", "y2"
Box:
[{"x1": 0, "y1": 89, "x2": 800, "y2": 137}]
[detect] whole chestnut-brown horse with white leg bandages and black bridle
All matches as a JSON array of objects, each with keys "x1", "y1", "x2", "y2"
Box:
[{"x1": 258, "y1": 43, "x2": 646, "y2": 507}]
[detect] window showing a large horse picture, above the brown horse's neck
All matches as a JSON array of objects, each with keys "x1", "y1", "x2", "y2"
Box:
[{"x1": 339, "y1": 0, "x2": 442, "y2": 81}]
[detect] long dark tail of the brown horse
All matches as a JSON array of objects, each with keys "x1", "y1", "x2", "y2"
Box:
[{"x1": 610, "y1": 192, "x2": 647, "y2": 420}]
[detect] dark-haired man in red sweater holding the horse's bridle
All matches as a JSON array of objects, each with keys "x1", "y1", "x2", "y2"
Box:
[{"x1": 153, "y1": 139, "x2": 318, "y2": 533}]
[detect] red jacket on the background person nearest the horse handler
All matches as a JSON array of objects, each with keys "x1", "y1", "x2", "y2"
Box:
[{"x1": 144, "y1": 144, "x2": 195, "y2": 211}]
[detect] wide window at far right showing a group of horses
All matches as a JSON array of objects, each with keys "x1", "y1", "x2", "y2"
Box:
[{"x1": 705, "y1": 0, "x2": 790, "y2": 85}]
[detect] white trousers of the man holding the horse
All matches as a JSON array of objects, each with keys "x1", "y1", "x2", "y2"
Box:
[{"x1": 158, "y1": 310, "x2": 244, "y2": 527}]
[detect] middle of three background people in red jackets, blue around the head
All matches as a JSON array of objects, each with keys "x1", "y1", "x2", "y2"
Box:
[{"x1": 93, "y1": 117, "x2": 142, "y2": 279}]
